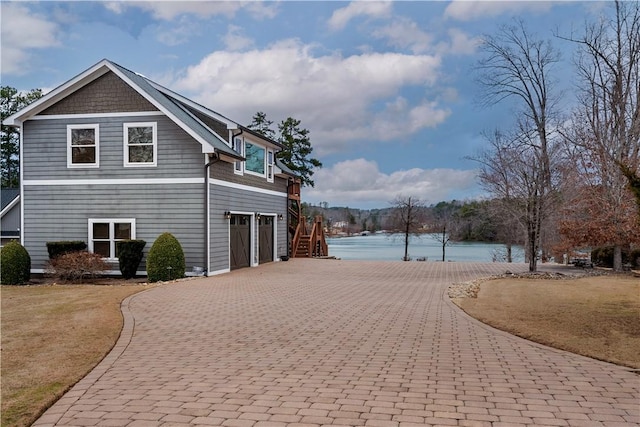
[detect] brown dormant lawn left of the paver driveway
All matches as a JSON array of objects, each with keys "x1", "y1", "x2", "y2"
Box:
[{"x1": 0, "y1": 284, "x2": 149, "y2": 427}]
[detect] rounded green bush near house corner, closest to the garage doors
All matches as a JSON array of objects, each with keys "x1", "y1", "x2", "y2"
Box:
[{"x1": 147, "y1": 233, "x2": 186, "y2": 282}]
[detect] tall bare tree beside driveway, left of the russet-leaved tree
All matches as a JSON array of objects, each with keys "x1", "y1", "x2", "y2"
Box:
[{"x1": 477, "y1": 21, "x2": 559, "y2": 271}]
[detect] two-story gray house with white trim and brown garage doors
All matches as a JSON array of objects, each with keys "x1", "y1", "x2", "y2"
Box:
[{"x1": 4, "y1": 60, "x2": 295, "y2": 275}]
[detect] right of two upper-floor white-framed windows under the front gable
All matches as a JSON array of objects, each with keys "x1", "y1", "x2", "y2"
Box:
[{"x1": 124, "y1": 122, "x2": 158, "y2": 166}]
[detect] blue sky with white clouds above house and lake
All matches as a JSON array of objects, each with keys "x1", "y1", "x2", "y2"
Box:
[{"x1": 0, "y1": 0, "x2": 607, "y2": 208}]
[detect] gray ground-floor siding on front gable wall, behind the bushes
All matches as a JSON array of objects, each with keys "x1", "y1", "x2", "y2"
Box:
[{"x1": 22, "y1": 184, "x2": 206, "y2": 271}]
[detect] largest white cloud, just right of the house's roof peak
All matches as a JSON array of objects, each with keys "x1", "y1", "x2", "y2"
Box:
[{"x1": 171, "y1": 40, "x2": 449, "y2": 155}]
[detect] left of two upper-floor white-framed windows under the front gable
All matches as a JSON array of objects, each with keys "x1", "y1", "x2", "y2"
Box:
[{"x1": 67, "y1": 124, "x2": 100, "y2": 168}]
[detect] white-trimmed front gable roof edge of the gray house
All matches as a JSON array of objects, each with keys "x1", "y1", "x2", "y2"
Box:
[{"x1": 3, "y1": 59, "x2": 244, "y2": 160}]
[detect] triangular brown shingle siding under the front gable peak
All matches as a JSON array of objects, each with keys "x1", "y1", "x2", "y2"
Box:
[{"x1": 41, "y1": 71, "x2": 158, "y2": 115}]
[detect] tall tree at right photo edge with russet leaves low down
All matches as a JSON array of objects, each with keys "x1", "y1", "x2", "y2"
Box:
[{"x1": 563, "y1": 1, "x2": 640, "y2": 270}]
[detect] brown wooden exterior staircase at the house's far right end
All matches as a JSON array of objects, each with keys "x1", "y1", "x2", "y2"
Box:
[{"x1": 288, "y1": 180, "x2": 329, "y2": 258}]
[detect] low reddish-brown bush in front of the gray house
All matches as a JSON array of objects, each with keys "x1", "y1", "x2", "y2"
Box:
[{"x1": 45, "y1": 251, "x2": 109, "y2": 283}]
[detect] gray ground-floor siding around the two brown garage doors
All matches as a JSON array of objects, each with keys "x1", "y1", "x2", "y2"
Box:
[{"x1": 210, "y1": 185, "x2": 287, "y2": 272}]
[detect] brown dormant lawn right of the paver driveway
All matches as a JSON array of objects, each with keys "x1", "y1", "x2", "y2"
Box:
[{"x1": 452, "y1": 275, "x2": 640, "y2": 369}]
